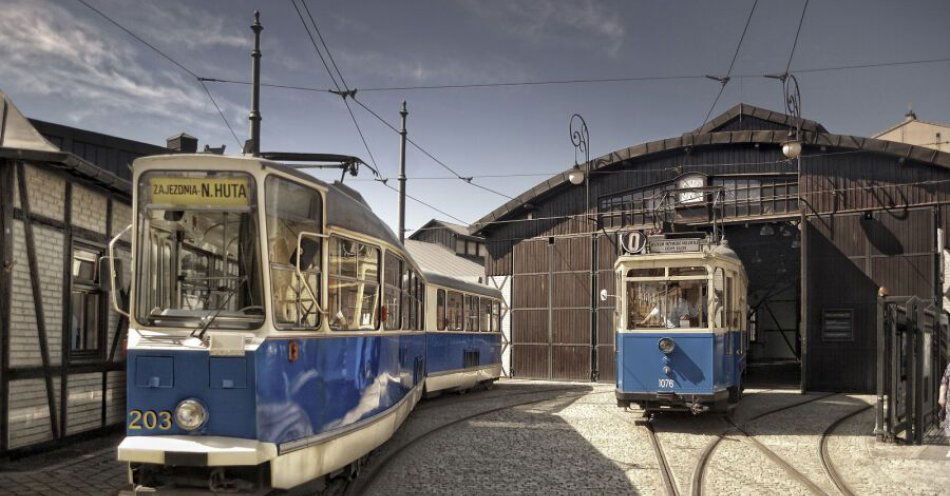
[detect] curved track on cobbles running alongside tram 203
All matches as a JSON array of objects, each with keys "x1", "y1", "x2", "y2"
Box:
[{"x1": 334, "y1": 387, "x2": 590, "y2": 496}]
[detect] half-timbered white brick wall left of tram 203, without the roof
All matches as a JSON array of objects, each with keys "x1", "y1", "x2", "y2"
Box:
[{"x1": 0, "y1": 160, "x2": 131, "y2": 452}]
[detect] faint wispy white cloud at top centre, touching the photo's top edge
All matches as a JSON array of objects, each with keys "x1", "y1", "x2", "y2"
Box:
[{"x1": 460, "y1": 0, "x2": 626, "y2": 57}]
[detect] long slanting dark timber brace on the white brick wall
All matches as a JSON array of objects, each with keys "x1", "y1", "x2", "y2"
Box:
[{"x1": 16, "y1": 162, "x2": 60, "y2": 438}]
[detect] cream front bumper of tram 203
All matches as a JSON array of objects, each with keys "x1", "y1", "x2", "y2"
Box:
[{"x1": 118, "y1": 436, "x2": 277, "y2": 467}]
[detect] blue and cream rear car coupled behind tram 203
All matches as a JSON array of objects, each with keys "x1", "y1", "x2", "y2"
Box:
[{"x1": 426, "y1": 272, "x2": 502, "y2": 394}]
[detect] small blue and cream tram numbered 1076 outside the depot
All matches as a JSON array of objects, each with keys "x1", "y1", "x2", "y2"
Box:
[{"x1": 614, "y1": 234, "x2": 748, "y2": 415}]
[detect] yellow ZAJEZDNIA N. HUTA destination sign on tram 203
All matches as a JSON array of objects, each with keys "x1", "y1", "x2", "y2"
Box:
[{"x1": 149, "y1": 177, "x2": 251, "y2": 207}]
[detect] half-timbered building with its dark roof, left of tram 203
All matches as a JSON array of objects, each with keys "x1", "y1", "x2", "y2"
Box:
[{"x1": 0, "y1": 93, "x2": 168, "y2": 456}]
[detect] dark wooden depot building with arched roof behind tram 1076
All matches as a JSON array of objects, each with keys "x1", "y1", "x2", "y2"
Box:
[{"x1": 472, "y1": 104, "x2": 950, "y2": 392}]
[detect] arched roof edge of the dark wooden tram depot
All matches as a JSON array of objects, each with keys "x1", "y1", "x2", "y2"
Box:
[{"x1": 469, "y1": 103, "x2": 950, "y2": 235}]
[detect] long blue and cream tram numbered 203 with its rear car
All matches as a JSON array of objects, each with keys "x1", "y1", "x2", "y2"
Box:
[{"x1": 110, "y1": 154, "x2": 500, "y2": 492}]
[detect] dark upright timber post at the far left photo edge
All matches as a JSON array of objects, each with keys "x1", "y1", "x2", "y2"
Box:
[{"x1": 0, "y1": 160, "x2": 13, "y2": 453}]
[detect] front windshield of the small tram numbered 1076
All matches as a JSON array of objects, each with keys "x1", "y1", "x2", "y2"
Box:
[{"x1": 626, "y1": 267, "x2": 708, "y2": 329}]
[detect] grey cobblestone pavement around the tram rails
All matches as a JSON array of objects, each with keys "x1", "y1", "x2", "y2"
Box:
[{"x1": 0, "y1": 380, "x2": 950, "y2": 496}]
